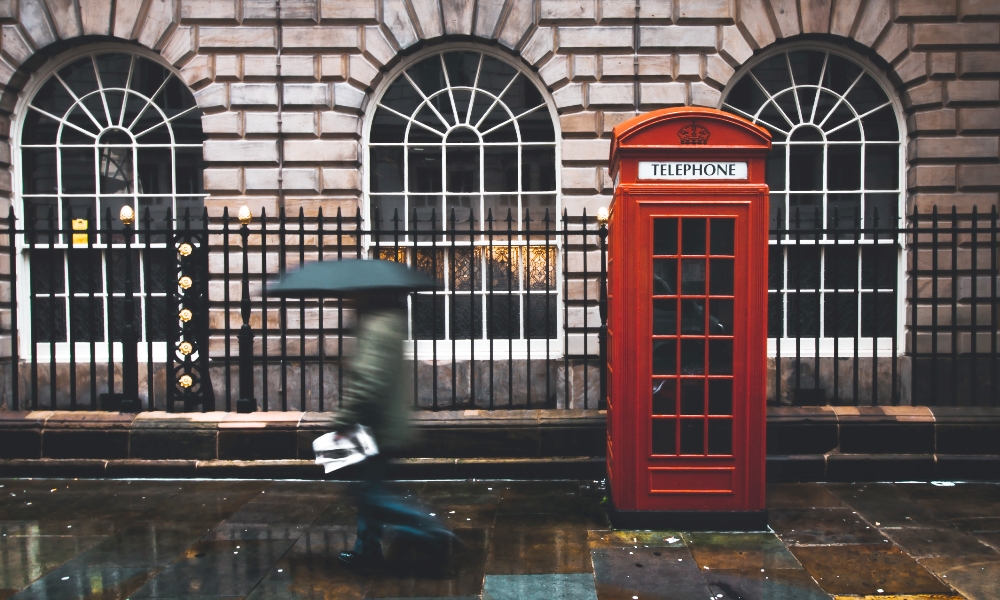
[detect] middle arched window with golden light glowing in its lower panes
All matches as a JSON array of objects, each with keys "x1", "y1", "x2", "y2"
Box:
[{"x1": 367, "y1": 50, "x2": 559, "y2": 340}]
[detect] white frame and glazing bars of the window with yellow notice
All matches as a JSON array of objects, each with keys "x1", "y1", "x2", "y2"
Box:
[{"x1": 11, "y1": 43, "x2": 208, "y2": 364}]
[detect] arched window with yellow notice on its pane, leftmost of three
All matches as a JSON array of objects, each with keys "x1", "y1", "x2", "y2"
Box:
[{"x1": 18, "y1": 50, "x2": 205, "y2": 354}]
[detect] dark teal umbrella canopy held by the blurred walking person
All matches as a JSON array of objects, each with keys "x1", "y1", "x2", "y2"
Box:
[{"x1": 267, "y1": 259, "x2": 441, "y2": 297}]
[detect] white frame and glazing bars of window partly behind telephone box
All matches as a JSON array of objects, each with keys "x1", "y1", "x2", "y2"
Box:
[{"x1": 720, "y1": 42, "x2": 909, "y2": 358}]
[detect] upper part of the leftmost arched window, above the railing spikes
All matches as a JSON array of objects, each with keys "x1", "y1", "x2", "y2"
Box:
[{"x1": 20, "y1": 51, "x2": 205, "y2": 227}]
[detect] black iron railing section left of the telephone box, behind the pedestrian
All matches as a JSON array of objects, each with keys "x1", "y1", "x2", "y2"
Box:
[{"x1": 5, "y1": 210, "x2": 607, "y2": 411}]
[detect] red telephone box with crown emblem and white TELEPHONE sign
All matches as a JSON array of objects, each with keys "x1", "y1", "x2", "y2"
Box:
[{"x1": 607, "y1": 108, "x2": 771, "y2": 529}]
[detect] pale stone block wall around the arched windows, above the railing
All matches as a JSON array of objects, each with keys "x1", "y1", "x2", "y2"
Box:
[{"x1": 0, "y1": 0, "x2": 1000, "y2": 400}]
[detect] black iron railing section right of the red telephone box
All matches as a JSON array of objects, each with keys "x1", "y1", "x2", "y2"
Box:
[{"x1": 768, "y1": 207, "x2": 1000, "y2": 406}]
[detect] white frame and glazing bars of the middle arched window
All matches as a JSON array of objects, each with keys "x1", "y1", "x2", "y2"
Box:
[{"x1": 361, "y1": 44, "x2": 568, "y2": 360}]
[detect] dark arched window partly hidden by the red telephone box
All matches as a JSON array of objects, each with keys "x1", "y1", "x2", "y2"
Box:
[{"x1": 723, "y1": 49, "x2": 902, "y2": 354}]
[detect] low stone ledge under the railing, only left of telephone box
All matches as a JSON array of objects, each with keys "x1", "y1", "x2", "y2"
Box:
[{"x1": 0, "y1": 410, "x2": 606, "y2": 461}]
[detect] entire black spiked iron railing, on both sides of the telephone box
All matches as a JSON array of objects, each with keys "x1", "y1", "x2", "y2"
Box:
[{"x1": 0, "y1": 207, "x2": 1000, "y2": 411}]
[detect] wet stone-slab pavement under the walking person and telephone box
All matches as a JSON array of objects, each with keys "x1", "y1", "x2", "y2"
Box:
[{"x1": 0, "y1": 479, "x2": 1000, "y2": 600}]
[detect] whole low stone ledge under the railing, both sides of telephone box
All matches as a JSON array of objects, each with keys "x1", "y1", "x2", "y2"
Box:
[{"x1": 0, "y1": 406, "x2": 1000, "y2": 468}]
